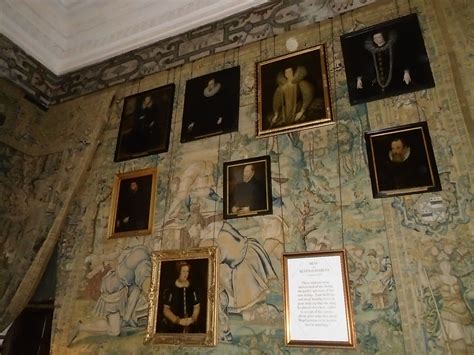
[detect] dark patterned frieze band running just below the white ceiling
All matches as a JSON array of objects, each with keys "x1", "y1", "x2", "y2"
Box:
[{"x1": 0, "y1": 0, "x2": 376, "y2": 105}]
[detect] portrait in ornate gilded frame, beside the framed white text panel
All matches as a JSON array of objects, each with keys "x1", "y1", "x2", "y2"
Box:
[{"x1": 145, "y1": 247, "x2": 218, "y2": 346}]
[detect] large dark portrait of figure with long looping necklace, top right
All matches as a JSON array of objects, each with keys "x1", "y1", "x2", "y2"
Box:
[{"x1": 341, "y1": 14, "x2": 435, "y2": 105}]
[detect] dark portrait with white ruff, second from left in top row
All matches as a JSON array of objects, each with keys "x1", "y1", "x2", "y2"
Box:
[{"x1": 181, "y1": 66, "x2": 240, "y2": 143}]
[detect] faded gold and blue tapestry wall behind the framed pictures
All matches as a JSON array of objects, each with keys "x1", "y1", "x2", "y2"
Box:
[{"x1": 2, "y1": 0, "x2": 474, "y2": 354}]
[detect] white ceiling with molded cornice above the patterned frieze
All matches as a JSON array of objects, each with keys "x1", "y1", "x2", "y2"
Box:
[{"x1": 0, "y1": 0, "x2": 270, "y2": 75}]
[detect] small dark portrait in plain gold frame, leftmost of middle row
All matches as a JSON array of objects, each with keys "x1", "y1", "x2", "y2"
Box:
[{"x1": 108, "y1": 168, "x2": 156, "y2": 238}]
